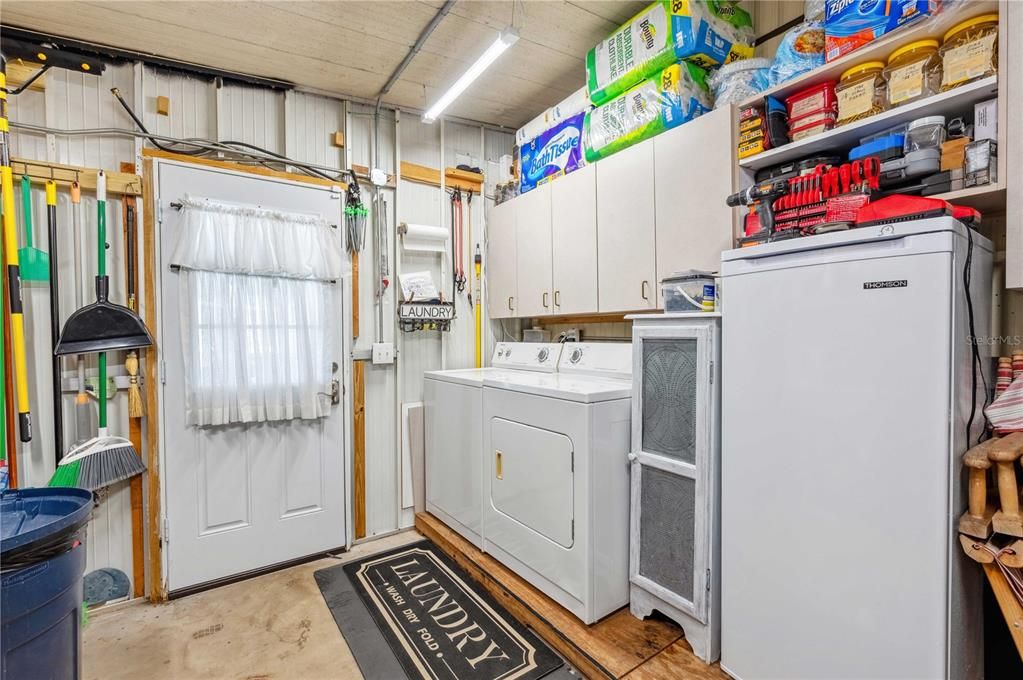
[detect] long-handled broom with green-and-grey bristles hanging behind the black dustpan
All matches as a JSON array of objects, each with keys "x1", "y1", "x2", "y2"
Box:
[{"x1": 49, "y1": 172, "x2": 145, "y2": 491}]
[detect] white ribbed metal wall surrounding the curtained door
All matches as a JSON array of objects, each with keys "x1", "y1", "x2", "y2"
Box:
[{"x1": 9, "y1": 59, "x2": 514, "y2": 588}]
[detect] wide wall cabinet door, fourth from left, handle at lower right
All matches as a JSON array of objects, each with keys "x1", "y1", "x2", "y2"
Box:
[{"x1": 596, "y1": 141, "x2": 658, "y2": 312}]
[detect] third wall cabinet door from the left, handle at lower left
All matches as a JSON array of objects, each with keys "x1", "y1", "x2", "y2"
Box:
[{"x1": 550, "y1": 166, "x2": 597, "y2": 314}]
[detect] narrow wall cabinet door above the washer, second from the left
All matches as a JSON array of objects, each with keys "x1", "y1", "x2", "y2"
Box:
[{"x1": 515, "y1": 183, "x2": 554, "y2": 316}]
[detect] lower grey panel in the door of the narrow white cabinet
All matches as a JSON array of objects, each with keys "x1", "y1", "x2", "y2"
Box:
[{"x1": 639, "y1": 465, "x2": 697, "y2": 602}]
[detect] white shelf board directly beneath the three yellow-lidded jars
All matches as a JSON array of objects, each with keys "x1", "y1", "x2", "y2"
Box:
[{"x1": 739, "y1": 76, "x2": 998, "y2": 170}]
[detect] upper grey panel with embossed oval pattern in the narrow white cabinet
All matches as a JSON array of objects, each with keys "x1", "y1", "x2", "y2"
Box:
[{"x1": 641, "y1": 337, "x2": 698, "y2": 464}]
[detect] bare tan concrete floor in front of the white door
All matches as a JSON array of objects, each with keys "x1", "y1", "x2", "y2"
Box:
[{"x1": 83, "y1": 531, "x2": 420, "y2": 680}]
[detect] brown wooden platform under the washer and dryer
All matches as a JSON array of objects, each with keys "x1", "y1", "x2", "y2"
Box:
[{"x1": 415, "y1": 512, "x2": 728, "y2": 680}]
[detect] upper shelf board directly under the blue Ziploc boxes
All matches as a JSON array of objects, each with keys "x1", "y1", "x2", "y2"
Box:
[{"x1": 740, "y1": 0, "x2": 998, "y2": 106}]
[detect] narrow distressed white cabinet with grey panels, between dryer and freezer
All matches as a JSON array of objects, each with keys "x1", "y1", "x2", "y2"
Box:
[{"x1": 628, "y1": 314, "x2": 721, "y2": 663}]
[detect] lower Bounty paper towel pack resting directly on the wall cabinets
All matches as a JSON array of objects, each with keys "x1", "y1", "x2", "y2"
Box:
[{"x1": 583, "y1": 61, "x2": 711, "y2": 163}]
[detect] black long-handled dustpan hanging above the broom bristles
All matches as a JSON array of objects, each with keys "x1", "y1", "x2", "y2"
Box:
[{"x1": 53, "y1": 170, "x2": 152, "y2": 356}]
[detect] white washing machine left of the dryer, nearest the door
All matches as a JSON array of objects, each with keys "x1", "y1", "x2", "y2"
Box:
[{"x1": 422, "y1": 343, "x2": 562, "y2": 548}]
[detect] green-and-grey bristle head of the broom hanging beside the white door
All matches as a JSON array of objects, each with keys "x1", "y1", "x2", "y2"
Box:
[{"x1": 49, "y1": 434, "x2": 145, "y2": 491}]
